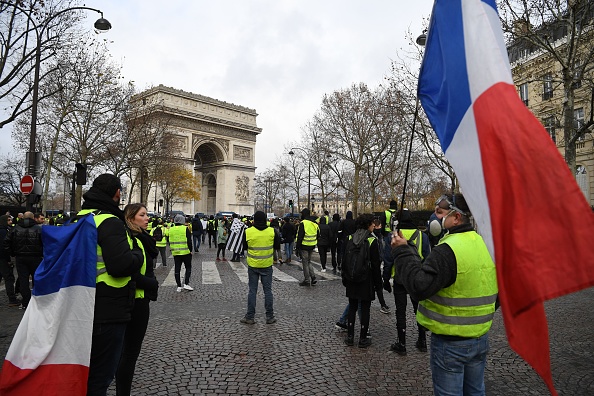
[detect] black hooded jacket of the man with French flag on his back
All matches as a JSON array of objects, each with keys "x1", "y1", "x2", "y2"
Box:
[{"x1": 82, "y1": 187, "x2": 144, "y2": 323}]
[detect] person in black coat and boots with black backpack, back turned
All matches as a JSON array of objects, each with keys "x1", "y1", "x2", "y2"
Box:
[{"x1": 342, "y1": 213, "x2": 382, "y2": 348}]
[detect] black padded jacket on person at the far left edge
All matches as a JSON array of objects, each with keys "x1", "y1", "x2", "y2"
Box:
[{"x1": 3, "y1": 219, "x2": 43, "y2": 258}]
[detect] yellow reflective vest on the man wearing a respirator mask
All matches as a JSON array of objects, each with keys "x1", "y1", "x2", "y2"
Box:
[{"x1": 417, "y1": 231, "x2": 498, "y2": 338}]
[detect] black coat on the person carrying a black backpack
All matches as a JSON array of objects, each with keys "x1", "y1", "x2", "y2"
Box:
[{"x1": 342, "y1": 229, "x2": 382, "y2": 301}]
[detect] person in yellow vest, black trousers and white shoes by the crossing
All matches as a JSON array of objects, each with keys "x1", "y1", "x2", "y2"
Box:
[{"x1": 169, "y1": 215, "x2": 194, "y2": 293}]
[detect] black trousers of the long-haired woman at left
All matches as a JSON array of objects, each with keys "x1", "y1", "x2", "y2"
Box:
[{"x1": 116, "y1": 298, "x2": 150, "y2": 396}]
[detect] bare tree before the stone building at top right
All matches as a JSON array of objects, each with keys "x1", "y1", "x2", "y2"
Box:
[{"x1": 497, "y1": 0, "x2": 594, "y2": 171}]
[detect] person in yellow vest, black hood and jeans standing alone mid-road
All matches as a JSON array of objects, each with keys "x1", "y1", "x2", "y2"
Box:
[{"x1": 240, "y1": 211, "x2": 280, "y2": 324}]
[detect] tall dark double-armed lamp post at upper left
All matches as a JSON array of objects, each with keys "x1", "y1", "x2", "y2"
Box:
[{"x1": 0, "y1": 1, "x2": 111, "y2": 210}]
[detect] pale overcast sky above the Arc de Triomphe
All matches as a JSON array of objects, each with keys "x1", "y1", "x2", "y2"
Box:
[{"x1": 0, "y1": 0, "x2": 433, "y2": 173}]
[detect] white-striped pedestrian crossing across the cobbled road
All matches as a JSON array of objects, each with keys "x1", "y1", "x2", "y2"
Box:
[{"x1": 161, "y1": 261, "x2": 341, "y2": 286}]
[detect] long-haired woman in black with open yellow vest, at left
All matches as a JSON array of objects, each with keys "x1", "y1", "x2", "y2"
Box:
[{"x1": 116, "y1": 203, "x2": 159, "y2": 396}]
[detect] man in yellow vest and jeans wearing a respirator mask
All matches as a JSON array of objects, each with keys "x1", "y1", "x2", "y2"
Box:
[{"x1": 392, "y1": 193, "x2": 498, "y2": 396}]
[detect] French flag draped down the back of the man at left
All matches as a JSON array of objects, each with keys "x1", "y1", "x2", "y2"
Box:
[{"x1": 0, "y1": 216, "x2": 97, "y2": 396}]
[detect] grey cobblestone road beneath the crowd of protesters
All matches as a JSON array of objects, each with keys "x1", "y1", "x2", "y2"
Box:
[{"x1": 0, "y1": 248, "x2": 594, "y2": 396}]
